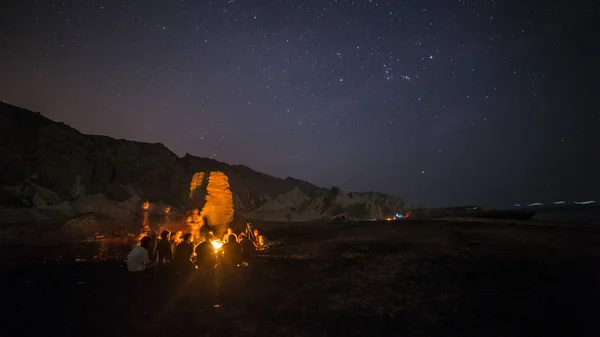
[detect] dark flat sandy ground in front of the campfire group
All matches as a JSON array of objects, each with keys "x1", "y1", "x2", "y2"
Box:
[{"x1": 0, "y1": 221, "x2": 600, "y2": 337}]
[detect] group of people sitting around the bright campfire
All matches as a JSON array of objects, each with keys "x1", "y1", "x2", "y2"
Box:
[{"x1": 127, "y1": 223, "x2": 268, "y2": 273}]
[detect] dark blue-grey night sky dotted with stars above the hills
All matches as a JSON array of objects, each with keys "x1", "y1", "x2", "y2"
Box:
[{"x1": 0, "y1": 0, "x2": 600, "y2": 207}]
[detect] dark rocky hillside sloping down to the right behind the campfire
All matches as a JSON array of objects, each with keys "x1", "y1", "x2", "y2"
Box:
[{"x1": 0, "y1": 103, "x2": 404, "y2": 222}]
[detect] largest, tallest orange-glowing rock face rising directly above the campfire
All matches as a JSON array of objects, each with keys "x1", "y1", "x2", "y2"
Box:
[{"x1": 200, "y1": 172, "x2": 234, "y2": 229}]
